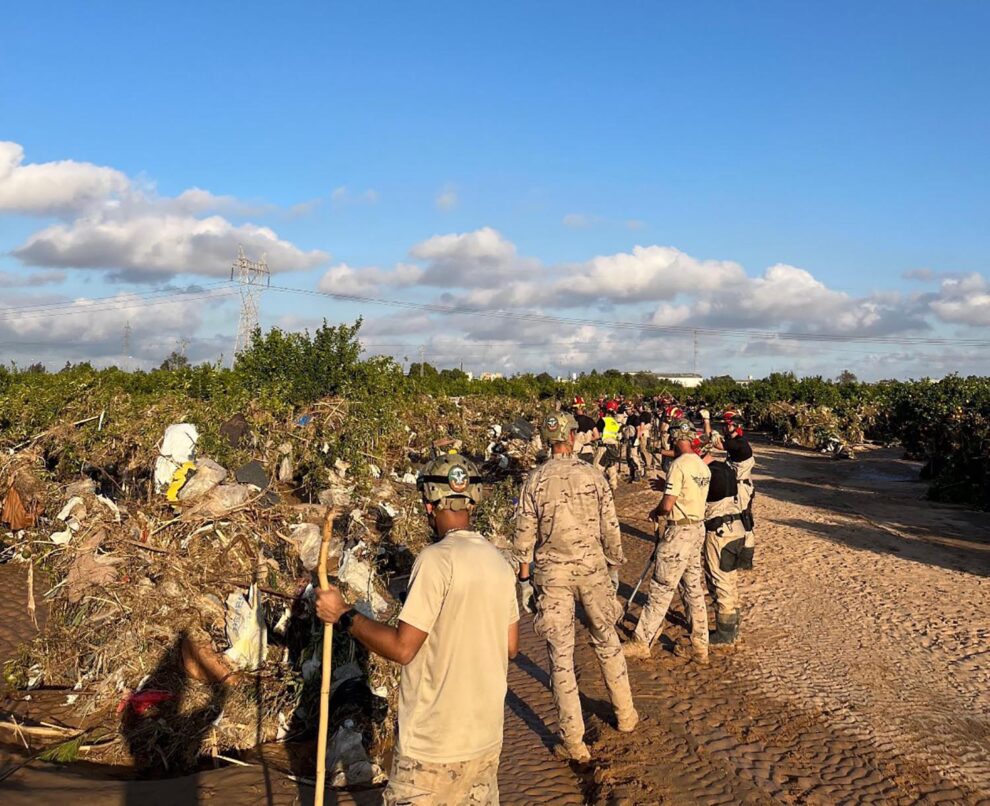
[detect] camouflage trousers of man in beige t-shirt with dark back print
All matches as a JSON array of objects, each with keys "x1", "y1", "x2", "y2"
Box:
[{"x1": 636, "y1": 523, "x2": 708, "y2": 646}]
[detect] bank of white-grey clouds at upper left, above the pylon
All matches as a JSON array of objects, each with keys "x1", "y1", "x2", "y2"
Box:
[{"x1": 0, "y1": 142, "x2": 329, "y2": 282}]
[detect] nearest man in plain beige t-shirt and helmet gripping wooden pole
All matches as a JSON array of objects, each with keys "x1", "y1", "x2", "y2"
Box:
[{"x1": 316, "y1": 454, "x2": 519, "y2": 806}]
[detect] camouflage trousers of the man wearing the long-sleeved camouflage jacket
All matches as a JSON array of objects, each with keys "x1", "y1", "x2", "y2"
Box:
[{"x1": 533, "y1": 572, "x2": 633, "y2": 744}]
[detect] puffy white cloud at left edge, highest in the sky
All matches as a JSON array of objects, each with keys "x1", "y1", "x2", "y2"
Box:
[{"x1": 0, "y1": 141, "x2": 131, "y2": 216}]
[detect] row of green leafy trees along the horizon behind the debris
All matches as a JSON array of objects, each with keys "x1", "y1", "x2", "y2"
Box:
[{"x1": 0, "y1": 320, "x2": 990, "y2": 507}]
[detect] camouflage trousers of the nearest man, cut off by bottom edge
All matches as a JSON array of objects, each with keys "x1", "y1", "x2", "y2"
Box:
[{"x1": 382, "y1": 750, "x2": 501, "y2": 806}]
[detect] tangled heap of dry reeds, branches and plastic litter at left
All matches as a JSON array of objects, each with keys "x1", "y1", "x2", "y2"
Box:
[{"x1": 0, "y1": 399, "x2": 539, "y2": 786}]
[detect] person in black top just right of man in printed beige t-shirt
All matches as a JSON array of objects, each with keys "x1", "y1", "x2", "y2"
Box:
[{"x1": 705, "y1": 452, "x2": 746, "y2": 645}]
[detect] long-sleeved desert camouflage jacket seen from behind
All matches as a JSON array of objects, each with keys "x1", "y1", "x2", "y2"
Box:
[{"x1": 512, "y1": 456, "x2": 625, "y2": 585}]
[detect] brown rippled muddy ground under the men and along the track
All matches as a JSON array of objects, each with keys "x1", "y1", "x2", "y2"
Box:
[{"x1": 0, "y1": 445, "x2": 990, "y2": 806}]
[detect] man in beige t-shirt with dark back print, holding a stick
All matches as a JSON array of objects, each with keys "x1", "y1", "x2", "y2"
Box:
[{"x1": 624, "y1": 420, "x2": 711, "y2": 663}]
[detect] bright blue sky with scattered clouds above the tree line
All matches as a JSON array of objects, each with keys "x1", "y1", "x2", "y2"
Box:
[{"x1": 0, "y1": 2, "x2": 990, "y2": 376}]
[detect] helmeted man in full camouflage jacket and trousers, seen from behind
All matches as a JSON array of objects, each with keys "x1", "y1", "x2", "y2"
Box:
[{"x1": 513, "y1": 415, "x2": 639, "y2": 761}]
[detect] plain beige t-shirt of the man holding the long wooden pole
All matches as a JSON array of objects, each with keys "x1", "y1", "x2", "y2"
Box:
[{"x1": 398, "y1": 530, "x2": 519, "y2": 762}]
